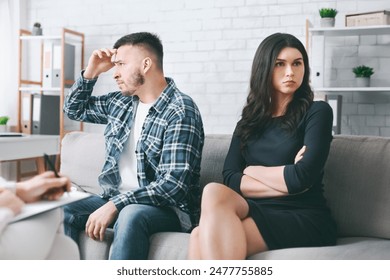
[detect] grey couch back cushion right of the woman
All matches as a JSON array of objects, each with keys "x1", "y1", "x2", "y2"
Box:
[{"x1": 324, "y1": 136, "x2": 390, "y2": 238}]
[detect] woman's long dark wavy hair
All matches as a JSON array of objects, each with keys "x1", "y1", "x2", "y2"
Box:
[{"x1": 235, "y1": 33, "x2": 314, "y2": 149}]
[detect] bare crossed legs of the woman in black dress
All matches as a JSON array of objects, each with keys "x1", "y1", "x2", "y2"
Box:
[{"x1": 189, "y1": 183, "x2": 267, "y2": 259}]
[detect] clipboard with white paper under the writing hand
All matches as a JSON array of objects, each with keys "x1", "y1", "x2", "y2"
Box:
[{"x1": 9, "y1": 191, "x2": 91, "y2": 223}]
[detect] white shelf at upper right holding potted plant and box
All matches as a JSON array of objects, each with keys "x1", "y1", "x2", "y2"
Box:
[{"x1": 309, "y1": 25, "x2": 390, "y2": 36}]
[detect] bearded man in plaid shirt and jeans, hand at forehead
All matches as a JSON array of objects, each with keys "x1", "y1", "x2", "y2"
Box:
[{"x1": 64, "y1": 32, "x2": 204, "y2": 259}]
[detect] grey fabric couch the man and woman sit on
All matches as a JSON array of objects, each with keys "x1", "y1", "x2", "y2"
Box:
[{"x1": 61, "y1": 132, "x2": 390, "y2": 260}]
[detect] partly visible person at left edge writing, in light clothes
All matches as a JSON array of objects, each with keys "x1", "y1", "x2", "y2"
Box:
[{"x1": 0, "y1": 171, "x2": 80, "y2": 260}]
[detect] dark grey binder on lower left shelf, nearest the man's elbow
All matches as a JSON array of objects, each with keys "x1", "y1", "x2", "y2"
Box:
[{"x1": 31, "y1": 94, "x2": 60, "y2": 135}]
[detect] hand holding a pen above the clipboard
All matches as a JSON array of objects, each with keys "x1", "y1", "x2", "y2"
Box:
[{"x1": 16, "y1": 171, "x2": 71, "y2": 203}]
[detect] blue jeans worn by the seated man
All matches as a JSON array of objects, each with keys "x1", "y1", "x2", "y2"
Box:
[{"x1": 64, "y1": 196, "x2": 181, "y2": 260}]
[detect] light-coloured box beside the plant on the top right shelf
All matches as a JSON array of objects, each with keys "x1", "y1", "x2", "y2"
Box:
[{"x1": 345, "y1": 10, "x2": 390, "y2": 27}]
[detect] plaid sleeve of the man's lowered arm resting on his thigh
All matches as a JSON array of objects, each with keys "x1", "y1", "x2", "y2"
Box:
[{"x1": 112, "y1": 117, "x2": 203, "y2": 211}]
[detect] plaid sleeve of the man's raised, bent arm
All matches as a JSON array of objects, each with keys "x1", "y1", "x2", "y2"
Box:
[{"x1": 63, "y1": 73, "x2": 109, "y2": 124}]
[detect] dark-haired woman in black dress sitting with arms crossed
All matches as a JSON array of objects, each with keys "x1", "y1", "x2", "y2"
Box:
[{"x1": 188, "y1": 33, "x2": 336, "y2": 259}]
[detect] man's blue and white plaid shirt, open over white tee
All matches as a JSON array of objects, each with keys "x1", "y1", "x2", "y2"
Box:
[{"x1": 64, "y1": 73, "x2": 204, "y2": 229}]
